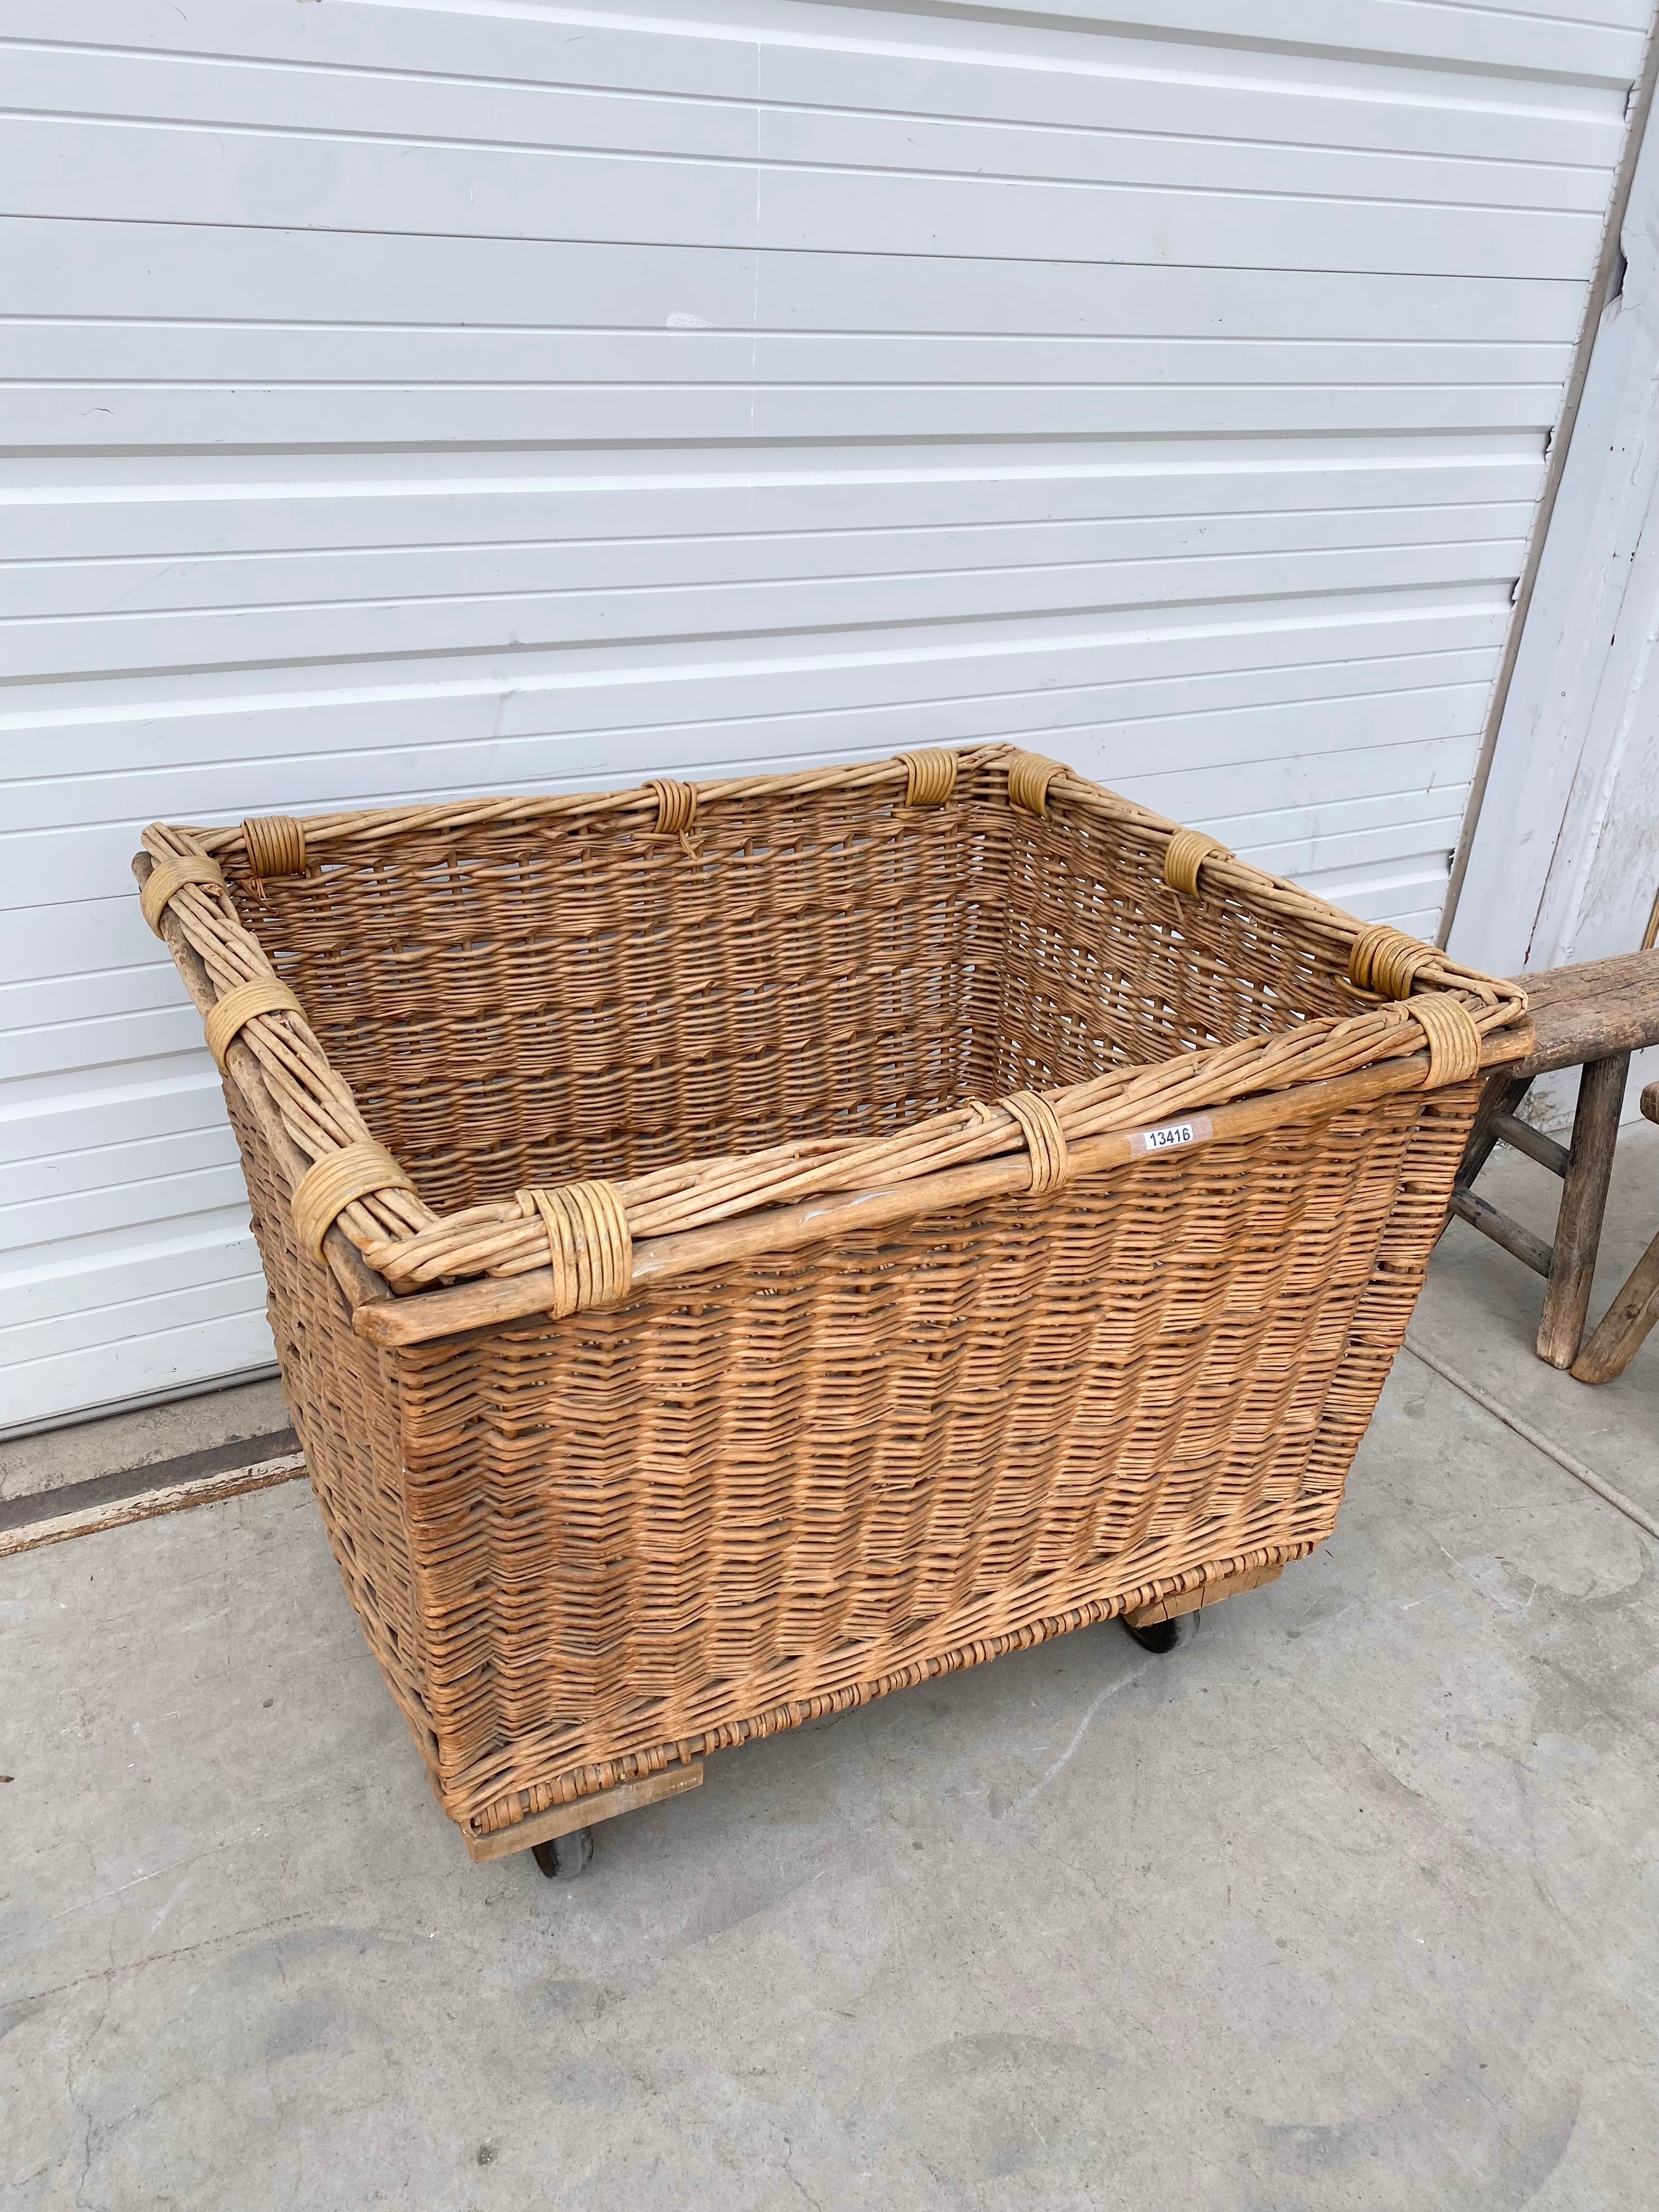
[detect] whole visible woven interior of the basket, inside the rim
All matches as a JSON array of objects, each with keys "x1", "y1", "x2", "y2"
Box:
[{"x1": 221, "y1": 770, "x2": 1356, "y2": 1212}]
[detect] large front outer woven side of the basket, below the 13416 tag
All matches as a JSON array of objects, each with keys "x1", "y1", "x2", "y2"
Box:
[{"x1": 398, "y1": 1086, "x2": 1475, "y2": 1825}]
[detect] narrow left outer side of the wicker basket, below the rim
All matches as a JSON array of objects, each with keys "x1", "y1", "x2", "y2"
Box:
[{"x1": 225, "y1": 1084, "x2": 436, "y2": 1763}]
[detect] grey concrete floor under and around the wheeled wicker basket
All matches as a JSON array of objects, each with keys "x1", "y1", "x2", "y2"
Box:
[{"x1": 0, "y1": 1130, "x2": 1659, "y2": 2212}]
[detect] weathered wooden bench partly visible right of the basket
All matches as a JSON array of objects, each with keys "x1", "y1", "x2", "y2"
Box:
[{"x1": 1451, "y1": 951, "x2": 1659, "y2": 1383}]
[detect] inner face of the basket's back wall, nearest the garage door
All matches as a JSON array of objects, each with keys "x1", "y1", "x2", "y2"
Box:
[{"x1": 209, "y1": 789, "x2": 1009, "y2": 1212}]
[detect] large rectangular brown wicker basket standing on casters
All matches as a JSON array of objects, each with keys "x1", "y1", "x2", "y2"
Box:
[{"x1": 135, "y1": 748, "x2": 1526, "y2": 1856}]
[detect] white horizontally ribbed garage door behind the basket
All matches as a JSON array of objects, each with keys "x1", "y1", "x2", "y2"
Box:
[{"x1": 0, "y1": 0, "x2": 1648, "y2": 1427}]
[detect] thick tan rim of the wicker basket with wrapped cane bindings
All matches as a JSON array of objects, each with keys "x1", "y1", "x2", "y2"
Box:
[{"x1": 133, "y1": 746, "x2": 1526, "y2": 1342}]
